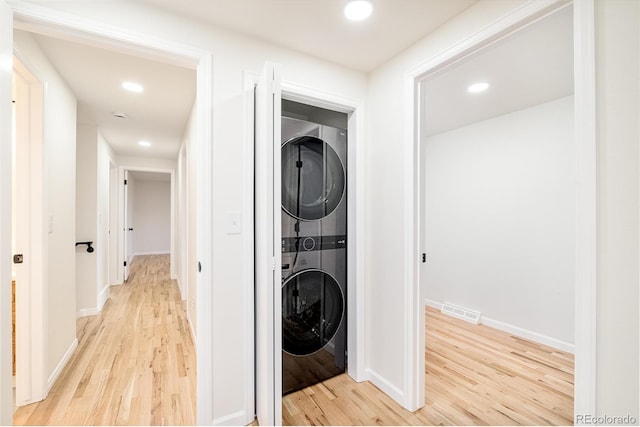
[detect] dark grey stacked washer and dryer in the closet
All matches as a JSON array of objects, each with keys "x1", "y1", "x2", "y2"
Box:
[{"x1": 281, "y1": 103, "x2": 347, "y2": 394}]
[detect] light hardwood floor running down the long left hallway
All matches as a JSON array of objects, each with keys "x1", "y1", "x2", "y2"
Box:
[{"x1": 14, "y1": 255, "x2": 196, "y2": 425}]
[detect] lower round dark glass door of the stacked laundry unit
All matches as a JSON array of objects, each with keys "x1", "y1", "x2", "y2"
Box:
[{"x1": 282, "y1": 270, "x2": 344, "y2": 356}]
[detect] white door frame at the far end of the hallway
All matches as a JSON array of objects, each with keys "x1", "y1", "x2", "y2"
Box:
[{"x1": 115, "y1": 166, "x2": 176, "y2": 284}]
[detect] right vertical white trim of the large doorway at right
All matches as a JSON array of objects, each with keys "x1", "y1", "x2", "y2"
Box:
[{"x1": 573, "y1": 0, "x2": 597, "y2": 415}]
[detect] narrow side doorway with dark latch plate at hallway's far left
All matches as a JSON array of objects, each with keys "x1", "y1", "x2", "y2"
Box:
[{"x1": 11, "y1": 56, "x2": 46, "y2": 405}]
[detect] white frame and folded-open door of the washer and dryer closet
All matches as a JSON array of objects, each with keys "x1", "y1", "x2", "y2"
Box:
[{"x1": 252, "y1": 63, "x2": 367, "y2": 425}]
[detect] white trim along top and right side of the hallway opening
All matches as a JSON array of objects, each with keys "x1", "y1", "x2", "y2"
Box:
[{"x1": 2, "y1": 5, "x2": 213, "y2": 424}]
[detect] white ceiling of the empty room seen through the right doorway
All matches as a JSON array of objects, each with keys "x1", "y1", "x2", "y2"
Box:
[{"x1": 423, "y1": 7, "x2": 573, "y2": 136}]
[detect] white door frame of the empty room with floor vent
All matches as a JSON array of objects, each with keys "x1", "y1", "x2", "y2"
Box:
[{"x1": 404, "y1": 0, "x2": 596, "y2": 414}]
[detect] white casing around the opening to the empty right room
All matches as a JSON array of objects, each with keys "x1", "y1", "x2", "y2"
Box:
[{"x1": 406, "y1": 2, "x2": 595, "y2": 413}]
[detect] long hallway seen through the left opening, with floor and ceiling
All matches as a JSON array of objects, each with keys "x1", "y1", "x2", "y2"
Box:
[{"x1": 12, "y1": 17, "x2": 205, "y2": 425}]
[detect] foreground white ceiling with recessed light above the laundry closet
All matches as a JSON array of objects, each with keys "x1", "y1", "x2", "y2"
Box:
[{"x1": 140, "y1": 0, "x2": 480, "y2": 72}]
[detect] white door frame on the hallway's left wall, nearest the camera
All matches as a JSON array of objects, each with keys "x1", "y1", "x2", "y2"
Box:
[{"x1": 13, "y1": 53, "x2": 48, "y2": 406}]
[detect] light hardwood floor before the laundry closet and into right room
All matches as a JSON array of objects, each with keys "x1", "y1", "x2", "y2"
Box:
[{"x1": 282, "y1": 308, "x2": 574, "y2": 425}]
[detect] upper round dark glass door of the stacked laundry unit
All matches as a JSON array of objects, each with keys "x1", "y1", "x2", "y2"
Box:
[{"x1": 282, "y1": 136, "x2": 345, "y2": 220}]
